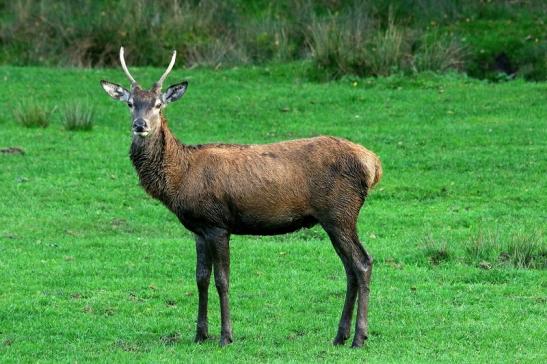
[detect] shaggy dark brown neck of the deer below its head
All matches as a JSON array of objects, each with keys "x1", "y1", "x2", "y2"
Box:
[{"x1": 130, "y1": 116, "x2": 188, "y2": 205}]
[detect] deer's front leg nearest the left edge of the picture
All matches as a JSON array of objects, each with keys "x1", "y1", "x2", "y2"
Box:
[{"x1": 194, "y1": 235, "x2": 212, "y2": 343}]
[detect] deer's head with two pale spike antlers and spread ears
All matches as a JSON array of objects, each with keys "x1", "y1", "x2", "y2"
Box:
[{"x1": 101, "y1": 47, "x2": 188, "y2": 138}]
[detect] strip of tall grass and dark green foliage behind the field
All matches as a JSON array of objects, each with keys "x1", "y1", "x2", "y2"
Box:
[{"x1": 0, "y1": 0, "x2": 547, "y2": 80}]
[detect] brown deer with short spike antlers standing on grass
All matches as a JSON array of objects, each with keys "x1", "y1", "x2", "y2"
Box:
[{"x1": 101, "y1": 47, "x2": 382, "y2": 347}]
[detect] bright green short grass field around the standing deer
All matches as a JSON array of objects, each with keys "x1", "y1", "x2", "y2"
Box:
[{"x1": 0, "y1": 64, "x2": 547, "y2": 363}]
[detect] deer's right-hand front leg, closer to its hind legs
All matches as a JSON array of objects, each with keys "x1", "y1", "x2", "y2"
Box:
[{"x1": 208, "y1": 231, "x2": 232, "y2": 346}]
